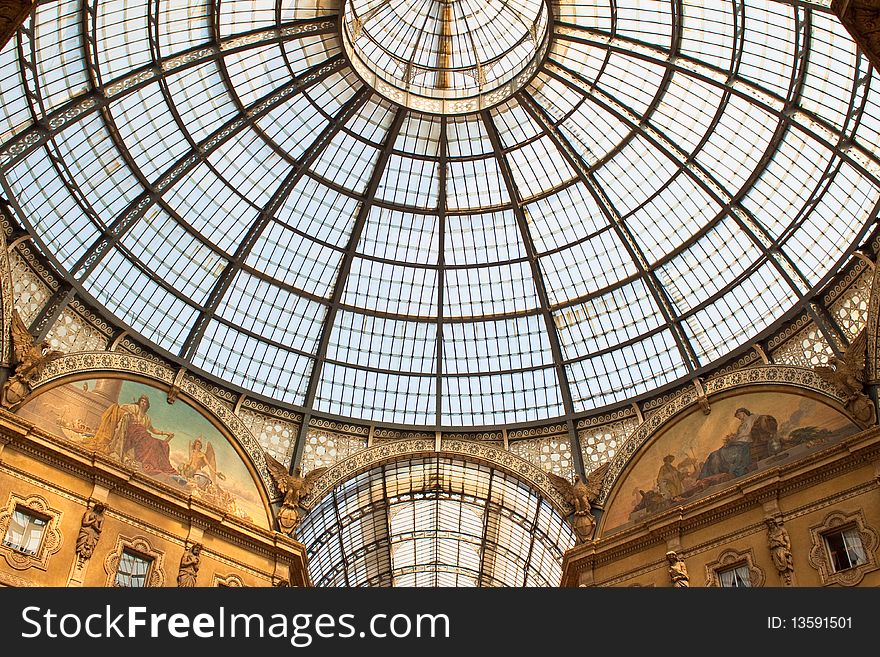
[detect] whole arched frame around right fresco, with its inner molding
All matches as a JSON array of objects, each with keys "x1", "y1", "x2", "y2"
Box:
[{"x1": 597, "y1": 366, "x2": 864, "y2": 536}]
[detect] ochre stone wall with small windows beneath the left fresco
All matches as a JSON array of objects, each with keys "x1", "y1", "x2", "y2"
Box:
[{"x1": 0, "y1": 411, "x2": 308, "y2": 587}]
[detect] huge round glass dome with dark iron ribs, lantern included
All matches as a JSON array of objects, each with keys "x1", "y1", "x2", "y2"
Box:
[{"x1": 0, "y1": 0, "x2": 880, "y2": 427}]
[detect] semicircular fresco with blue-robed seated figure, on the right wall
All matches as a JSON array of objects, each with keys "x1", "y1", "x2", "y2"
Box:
[{"x1": 603, "y1": 391, "x2": 859, "y2": 530}]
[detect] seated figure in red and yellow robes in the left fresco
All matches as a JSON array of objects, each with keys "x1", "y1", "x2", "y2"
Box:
[{"x1": 94, "y1": 395, "x2": 177, "y2": 476}]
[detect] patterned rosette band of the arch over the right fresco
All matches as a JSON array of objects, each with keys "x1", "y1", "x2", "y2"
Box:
[{"x1": 597, "y1": 365, "x2": 846, "y2": 505}]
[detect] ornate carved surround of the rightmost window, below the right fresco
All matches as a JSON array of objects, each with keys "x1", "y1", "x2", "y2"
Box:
[{"x1": 809, "y1": 509, "x2": 880, "y2": 586}]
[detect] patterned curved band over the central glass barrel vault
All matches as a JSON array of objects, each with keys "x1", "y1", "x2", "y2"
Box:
[{"x1": 300, "y1": 436, "x2": 574, "y2": 516}]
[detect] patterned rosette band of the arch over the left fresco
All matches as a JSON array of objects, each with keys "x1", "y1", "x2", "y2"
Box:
[{"x1": 24, "y1": 351, "x2": 274, "y2": 491}]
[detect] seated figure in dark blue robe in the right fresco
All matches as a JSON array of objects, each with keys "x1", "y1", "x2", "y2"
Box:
[{"x1": 697, "y1": 408, "x2": 777, "y2": 481}]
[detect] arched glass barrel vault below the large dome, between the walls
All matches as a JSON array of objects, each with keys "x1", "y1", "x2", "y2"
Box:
[{"x1": 297, "y1": 456, "x2": 575, "y2": 586}]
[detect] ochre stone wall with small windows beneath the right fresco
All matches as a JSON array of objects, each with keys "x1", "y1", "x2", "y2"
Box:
[{"x1": 563, "y1": 427, "x2": 880, "y2": 587}]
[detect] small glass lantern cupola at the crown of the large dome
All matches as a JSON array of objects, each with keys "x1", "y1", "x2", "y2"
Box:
[{"x1": 342, "y1": 0, "x2": 549, "y2": 114}]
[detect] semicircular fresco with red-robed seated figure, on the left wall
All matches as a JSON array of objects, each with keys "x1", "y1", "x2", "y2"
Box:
[{"x1": 19, "y1": 378, "x2": 268, "y2": 527}]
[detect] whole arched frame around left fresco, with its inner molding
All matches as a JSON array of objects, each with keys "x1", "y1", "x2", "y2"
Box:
[{"x1": 12, "y1": 352, "x2": 277, "y2": 527}]
